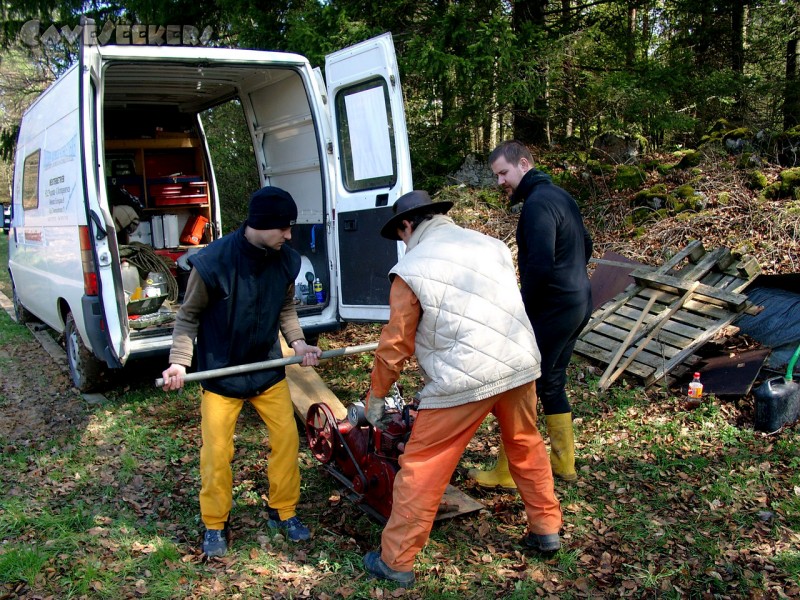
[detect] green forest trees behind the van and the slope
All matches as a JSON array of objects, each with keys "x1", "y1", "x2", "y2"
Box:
[{"x1": 0, "y1": 0, "x2": 800, "y2": 202}]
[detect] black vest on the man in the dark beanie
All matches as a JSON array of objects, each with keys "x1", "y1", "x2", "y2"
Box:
[{"x1": 189, "y1": 226, "x2": 300, "y2": 398}]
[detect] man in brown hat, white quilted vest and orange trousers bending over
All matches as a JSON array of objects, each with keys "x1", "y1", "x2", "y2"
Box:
[{"x1": 364, "y1": 191, "x2": 561, "y2": 587}]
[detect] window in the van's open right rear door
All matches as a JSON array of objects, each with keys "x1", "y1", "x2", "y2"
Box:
[{"x1": 336, "y1": 78, "x2": 397, "y2": 192}]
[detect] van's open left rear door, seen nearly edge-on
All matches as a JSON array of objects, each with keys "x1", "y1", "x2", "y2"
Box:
[{"x1": 79, "y1": 39, "x2": 129, "y2": 367}]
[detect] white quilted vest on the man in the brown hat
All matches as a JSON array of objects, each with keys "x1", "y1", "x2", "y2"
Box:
[{"x1": 391, "y1": 215, "x2": 541, "y2": 408}]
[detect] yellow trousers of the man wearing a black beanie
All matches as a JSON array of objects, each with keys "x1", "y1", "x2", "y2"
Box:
[{"x1": 200, "y1": 379, "x2": 300, "y2": 529}]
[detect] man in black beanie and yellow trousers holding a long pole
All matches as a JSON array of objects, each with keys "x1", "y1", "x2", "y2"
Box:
[{"x1": 164, "y1": 186, "x2": 322, "y2": 557}]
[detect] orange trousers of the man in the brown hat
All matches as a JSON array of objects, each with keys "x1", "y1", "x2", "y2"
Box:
[{"x1": 381, "y1": 383, "x2": 562, "y2": 571}]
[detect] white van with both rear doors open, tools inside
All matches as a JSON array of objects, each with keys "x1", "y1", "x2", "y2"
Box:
[{"x1": 9, "y1": 34, "x2": 412, "y2": 391}]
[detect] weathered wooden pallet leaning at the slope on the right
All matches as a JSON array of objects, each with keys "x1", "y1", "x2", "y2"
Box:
[{"x1": 575, "y1": 241, "x2": 761, "y2": 390}]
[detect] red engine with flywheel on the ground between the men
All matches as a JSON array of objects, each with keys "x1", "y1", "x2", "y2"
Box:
[{"x1": 306, "y1": 394, "x2": 416, "y2": 523}]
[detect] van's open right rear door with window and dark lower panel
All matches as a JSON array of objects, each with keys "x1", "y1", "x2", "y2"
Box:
[{"x1": 325, "y1": 33, "x2": 412, "y2": 321}]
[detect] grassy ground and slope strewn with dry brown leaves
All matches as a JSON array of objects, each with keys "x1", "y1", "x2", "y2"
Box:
[{"x1": 0, "y1": 148, "x2": 800, "y2": 599}]
